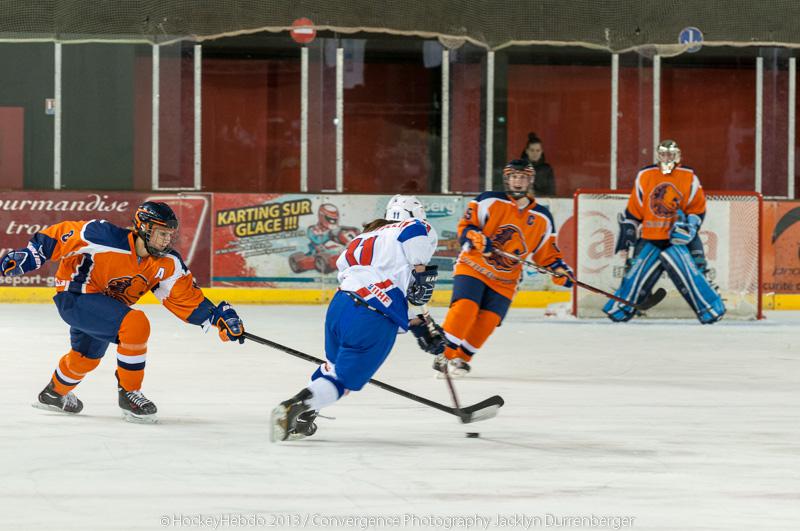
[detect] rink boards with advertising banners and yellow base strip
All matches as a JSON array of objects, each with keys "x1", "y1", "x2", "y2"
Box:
[{"x1": 0, "y1": 191, "x2": 800, "y2": 309}]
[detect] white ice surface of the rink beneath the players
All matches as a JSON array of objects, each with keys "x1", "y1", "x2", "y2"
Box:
[{"x1": 0, "y1": 305, "x2": 800, "y2": 530}]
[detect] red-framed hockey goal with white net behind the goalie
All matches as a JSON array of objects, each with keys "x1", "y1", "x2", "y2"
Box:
[{"x1": 572, "y1": 190, "x2": 762, "y2": 319}]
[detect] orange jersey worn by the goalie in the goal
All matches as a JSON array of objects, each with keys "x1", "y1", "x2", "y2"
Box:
[{"x1": 628, "y1": 165, "x2": 706, "y2": 240}]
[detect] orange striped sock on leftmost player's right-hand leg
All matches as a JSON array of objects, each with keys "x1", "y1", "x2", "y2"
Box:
[{"x1": 117, "y1": 310, "x2": 150, "y2": 391}]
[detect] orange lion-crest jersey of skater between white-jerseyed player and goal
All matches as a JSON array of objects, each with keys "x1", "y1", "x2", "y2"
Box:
[{"x1": 453, "y1": 192, "x2": 563, "y2": 299}]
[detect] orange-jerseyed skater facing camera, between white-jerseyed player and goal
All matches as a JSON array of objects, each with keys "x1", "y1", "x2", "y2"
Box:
[{"x1": 433, "y1": 160, "x2": 573, "y2": 376}]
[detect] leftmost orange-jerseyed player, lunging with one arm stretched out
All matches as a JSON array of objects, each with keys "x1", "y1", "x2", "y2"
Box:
[{"x1": 0, "y1": 201, "x2": 244, "y2": 422}]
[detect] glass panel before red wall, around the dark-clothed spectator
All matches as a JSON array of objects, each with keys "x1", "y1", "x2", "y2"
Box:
[{"x1": 504, "y1": 46, "x2": 611, "y2": 197}]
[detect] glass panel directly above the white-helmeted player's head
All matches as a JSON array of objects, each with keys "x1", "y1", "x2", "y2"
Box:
[{"x1": 340, "y1": 35, "x2": 442, "y2": 194}]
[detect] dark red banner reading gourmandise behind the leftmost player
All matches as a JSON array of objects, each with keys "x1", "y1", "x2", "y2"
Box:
[{"x1": 0, "y1": 191, "x2": 211, "y2": 287}]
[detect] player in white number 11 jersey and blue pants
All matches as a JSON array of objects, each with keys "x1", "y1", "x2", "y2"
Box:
[{"x1": 270, "y1": 195, "x2": 444, "y2": 442}]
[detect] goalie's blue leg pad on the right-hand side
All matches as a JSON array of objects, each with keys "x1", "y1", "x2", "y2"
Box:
[{"x1": 660, "y1": 245, "x2": 725, "y2": 324}]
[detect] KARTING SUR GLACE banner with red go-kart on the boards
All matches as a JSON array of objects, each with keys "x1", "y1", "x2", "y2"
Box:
[{"x1": 212, "y1": 194, "x2": 463, "y2": 289}]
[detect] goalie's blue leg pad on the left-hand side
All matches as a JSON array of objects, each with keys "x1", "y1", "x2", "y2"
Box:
[{"x1": 603, "y1": 241, "x2": 664, "y2": 322}]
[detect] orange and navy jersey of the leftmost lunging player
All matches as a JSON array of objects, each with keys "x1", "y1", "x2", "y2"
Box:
[{"x1": 25, "y1": 220, "x2": 214, "y2": 325}]
